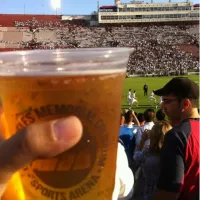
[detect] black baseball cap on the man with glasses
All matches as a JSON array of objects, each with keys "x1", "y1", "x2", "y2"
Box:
[{"x1": 154, "y1": 77, "x2": 199, "y2": 99}]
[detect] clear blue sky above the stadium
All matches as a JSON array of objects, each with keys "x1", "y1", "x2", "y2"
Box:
[{"x1": 0, "y1": 0, "x2": 198, "y2": 15}]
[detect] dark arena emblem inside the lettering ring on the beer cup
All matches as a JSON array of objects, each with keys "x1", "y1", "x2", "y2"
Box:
[{"x1": 31, "y1": 132, "x2": 96, "y2": 189}]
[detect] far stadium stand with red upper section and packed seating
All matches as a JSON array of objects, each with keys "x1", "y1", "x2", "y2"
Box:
[{"x1": 0, "y1": 15, "x2": 199, "y2": 76}]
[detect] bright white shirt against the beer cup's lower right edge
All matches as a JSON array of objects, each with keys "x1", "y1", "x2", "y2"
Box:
[{"x1": 112, "y1": 143, "x2": 134, "y2": 200}]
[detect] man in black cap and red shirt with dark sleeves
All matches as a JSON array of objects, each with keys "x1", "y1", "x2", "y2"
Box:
[{"x1": 152, "y1": 77, "x2": 199, "y2": 200}]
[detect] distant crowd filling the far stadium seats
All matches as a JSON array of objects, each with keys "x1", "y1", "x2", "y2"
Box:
[{"x1": 0, "y1": 20, "x2": 199, "y2": 76}]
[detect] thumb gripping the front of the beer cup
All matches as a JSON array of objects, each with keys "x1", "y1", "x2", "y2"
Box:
[{"x1": 0, "y1": 117, "x2": 82, "y2": 180}]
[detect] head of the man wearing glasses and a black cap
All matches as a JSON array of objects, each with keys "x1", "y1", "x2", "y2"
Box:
[{"x1": 154, "y1": 77, "x2": 199, "y2": 124}]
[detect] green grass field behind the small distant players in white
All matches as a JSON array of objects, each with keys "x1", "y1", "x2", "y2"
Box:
[{"x1": 121, "y1": 75, "x2": 199, "y2": 113}]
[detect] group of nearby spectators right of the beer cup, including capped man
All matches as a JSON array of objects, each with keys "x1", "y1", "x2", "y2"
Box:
[{"x1": 119, "y1": 77, "x2": 199, "y2": 200}]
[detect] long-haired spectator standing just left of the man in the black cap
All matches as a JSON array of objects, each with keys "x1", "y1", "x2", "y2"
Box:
[{"x1": 133, "y1": 121, "x2": 172, "y2": 200}]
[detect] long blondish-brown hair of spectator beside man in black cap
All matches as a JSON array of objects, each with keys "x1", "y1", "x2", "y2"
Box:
[{"x1": 149, "y1": 121, "x2": 172, "y2": 153}]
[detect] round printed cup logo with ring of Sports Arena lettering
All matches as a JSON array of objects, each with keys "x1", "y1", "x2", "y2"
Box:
[{"x1": 16, "y1": 104, "x2": 109, "y2": 200}]
